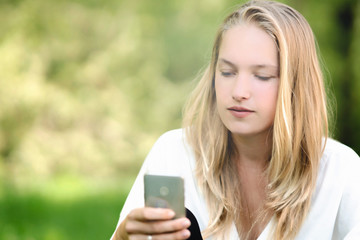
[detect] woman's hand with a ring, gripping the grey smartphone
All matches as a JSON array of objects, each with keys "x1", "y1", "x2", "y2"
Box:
[{"x1": 115, "y1": 207, "x2": 190, "y2": 240}]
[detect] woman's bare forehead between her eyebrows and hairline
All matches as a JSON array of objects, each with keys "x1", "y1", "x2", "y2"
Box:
[{"x1": 219, "y1": 24, "x2": 278, "y2": 66}]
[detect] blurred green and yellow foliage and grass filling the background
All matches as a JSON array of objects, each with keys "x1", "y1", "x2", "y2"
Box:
[{"x1": 0, "y1": 0, "x2": 360, "y2": 239}]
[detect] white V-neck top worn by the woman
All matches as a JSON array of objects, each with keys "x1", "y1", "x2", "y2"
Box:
[{"x1": 114, "y1": 129, "x2": 360, "y2": 240}]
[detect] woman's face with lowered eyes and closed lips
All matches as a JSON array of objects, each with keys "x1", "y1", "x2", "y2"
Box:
[{"x1": 215, "y1": 24, "x2": 279, "y2": 137}]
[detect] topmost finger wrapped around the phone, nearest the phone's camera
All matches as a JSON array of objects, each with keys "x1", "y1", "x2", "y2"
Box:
[{"x1": 128, "y1": 207, "x2": 175, "y2": 221}]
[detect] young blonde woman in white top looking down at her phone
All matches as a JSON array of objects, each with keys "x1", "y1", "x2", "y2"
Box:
[{"x1": 113, "y1": 1, "x2": 360, "y2": 240}]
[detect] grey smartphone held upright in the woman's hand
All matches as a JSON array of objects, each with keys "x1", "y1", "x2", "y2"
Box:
[{"x1": 144, "y1": 174, "x2": 185, "y2": 218}]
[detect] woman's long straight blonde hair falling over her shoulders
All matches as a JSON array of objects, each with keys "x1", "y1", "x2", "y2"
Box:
[{"x1": 183, "y1": 1, "x2": 328, "y2": 239}]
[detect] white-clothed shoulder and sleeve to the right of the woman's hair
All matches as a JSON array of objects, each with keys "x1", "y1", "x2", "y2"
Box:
[{"x1": 296, "y1": 139, "x2": 360, "y2": 239}]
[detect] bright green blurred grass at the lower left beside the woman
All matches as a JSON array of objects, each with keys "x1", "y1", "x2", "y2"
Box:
[{"x1": 0, "y1": 174, "x2": 133, "y2": 240}]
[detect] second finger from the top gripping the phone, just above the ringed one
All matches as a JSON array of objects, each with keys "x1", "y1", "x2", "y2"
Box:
[{"x1": 125, "y1": 218, "x2": 191, "y2": 234}]
